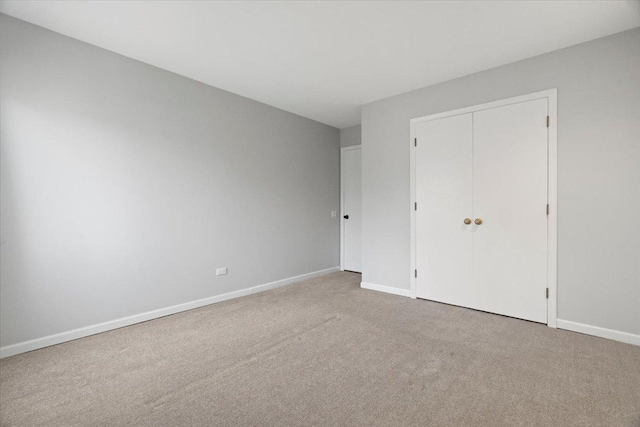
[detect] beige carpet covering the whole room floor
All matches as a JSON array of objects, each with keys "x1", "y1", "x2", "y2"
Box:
[{"x1": 0, "y1": 273, "x2": 640, "y2": 426}]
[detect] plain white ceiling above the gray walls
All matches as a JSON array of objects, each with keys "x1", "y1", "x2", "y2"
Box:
[{"x1": 0, "y1": 1, "x2": 640, "y2": 128}]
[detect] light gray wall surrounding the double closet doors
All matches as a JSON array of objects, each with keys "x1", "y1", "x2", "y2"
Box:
[{"x1": 362, "y1": 29, "x2": 640, "y2": 334}]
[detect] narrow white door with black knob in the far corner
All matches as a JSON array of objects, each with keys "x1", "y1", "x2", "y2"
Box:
[{"x1": 340, "y1": 146, "x2": 362, "y2": 272}]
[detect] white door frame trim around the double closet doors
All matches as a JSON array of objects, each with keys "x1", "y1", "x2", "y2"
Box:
[{"x1": 409, "y1": 88, "x2": 558, "y2": 328}]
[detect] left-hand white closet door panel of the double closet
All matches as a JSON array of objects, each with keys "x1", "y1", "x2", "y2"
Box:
[{"x1": 415, "y1": 114, "x2": 473, "y2": 306}]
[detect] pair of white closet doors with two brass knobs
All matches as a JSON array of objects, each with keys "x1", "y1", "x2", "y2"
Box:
[{"x1": 415, "y1": 99, "x2": 548, "y2": 323}]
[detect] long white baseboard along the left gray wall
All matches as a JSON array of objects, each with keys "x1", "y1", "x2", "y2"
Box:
[{"x1": 0, "y1": 267, "x2": 340, "y2": 359}]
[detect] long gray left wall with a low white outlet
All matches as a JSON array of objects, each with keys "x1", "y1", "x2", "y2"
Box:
[{"x1": 0, "y1": 15, "x2": 340, "y2": 346}]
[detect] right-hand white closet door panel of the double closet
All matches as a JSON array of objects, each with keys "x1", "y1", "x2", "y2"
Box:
[{"x1": 469, "y1": 99, "x2": 547, "y2": 323}]
